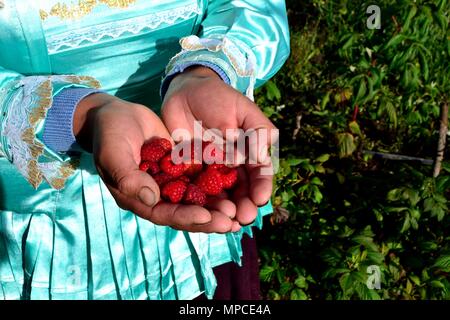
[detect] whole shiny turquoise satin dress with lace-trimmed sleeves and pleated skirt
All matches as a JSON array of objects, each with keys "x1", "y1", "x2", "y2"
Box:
[{"x1": 0, "y1": 0, "x2": 289, "y2": 299}]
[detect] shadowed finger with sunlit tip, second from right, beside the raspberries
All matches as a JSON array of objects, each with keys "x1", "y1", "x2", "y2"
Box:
[{"x1": 233, "y1": 168, "x2": 258, "y2": 225}]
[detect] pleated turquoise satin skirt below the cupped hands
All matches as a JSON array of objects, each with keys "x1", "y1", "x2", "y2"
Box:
[{"x1": 0, "y1": 154, "x2": 271, "y2": 300}]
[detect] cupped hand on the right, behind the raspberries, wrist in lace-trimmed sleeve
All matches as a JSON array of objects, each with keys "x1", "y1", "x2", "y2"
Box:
[{"x1": 162, "y1": 67, "x2": 277, "y2": 225}]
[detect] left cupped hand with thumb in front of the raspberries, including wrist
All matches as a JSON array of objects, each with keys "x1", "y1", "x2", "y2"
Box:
[{"x1": 73, "y1": 93, "x2": 240, "y2": 233}]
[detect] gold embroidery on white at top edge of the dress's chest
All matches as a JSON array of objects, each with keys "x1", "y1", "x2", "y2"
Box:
[{"x1": 40, "y1": 0, "x2": 137, "y2": 20}]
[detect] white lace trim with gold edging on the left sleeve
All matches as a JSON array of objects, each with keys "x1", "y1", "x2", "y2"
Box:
[{"x1": 0, "y1": 76, "x2": 98, "y2": 189}]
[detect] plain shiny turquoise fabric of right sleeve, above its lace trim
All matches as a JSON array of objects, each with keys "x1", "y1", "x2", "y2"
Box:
[{"x1": 200, "y1": 0, "x2": 290, "y2": 86}]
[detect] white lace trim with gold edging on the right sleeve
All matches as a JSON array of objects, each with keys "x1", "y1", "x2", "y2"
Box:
[{"x1": 166, "y1": 35, "x2": 256, "y2": 100}]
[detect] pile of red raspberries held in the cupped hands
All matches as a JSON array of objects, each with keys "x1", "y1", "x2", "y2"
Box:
[{"x1": 139, "y1": 138, "x2": 237, "y2": 206}]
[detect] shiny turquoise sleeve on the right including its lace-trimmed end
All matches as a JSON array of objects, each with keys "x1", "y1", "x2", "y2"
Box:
[{"x1": 166, "y1": 0, "x2": 289, "y2": 98}]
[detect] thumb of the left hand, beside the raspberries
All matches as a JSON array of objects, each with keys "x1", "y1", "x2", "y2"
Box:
[{"x1": 94, "y1": 136, "x2": 160, "y2": 206}]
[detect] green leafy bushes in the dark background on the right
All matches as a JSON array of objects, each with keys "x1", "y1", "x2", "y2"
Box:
[{"x1": 257, "y1": 0, "x2": 450, "y2": 299}]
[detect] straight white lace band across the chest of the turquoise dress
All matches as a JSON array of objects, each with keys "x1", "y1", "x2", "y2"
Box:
[{"x1": 47, "y1": 4, "x2": 201, "y2": 53}]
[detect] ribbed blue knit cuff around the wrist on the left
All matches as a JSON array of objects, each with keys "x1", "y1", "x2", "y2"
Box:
[{"x1": 42, "y1": 88, "x2": 100, "y2": 152}]
